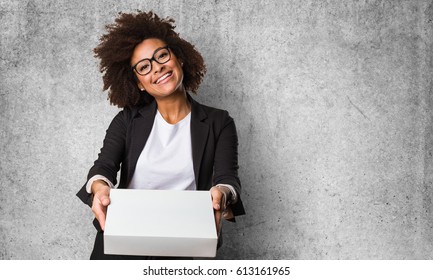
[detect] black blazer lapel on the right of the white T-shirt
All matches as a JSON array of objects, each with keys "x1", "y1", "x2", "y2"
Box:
[{"x1": 188, "y1": 95, "x2": 209, "y2": 189}]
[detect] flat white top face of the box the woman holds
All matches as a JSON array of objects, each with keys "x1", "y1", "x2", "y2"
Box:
[{"x1": 104, "y1": 189, "x2": 218, "y2": 240}]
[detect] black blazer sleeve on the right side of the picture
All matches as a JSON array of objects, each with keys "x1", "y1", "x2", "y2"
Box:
[{"x1": 214, "y1": 111, "x2": 245, "y2": 216}]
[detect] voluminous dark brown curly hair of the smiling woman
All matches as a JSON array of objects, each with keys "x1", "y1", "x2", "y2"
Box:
[{"x1": 93, "y1": 10, "x2": 206, "y2": 108}]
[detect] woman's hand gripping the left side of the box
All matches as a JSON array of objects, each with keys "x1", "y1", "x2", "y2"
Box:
[{"x1": 92, "y1": 180, "x2": 110, "y2": 230}]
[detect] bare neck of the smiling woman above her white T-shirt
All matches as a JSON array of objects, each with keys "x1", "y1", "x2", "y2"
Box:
[{"x1": 156, "y1": 87, "x2": 191, "y2": 124}]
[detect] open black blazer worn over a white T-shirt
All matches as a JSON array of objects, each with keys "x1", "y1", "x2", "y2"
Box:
[{"x1": 77, "y1": 95, "x2": 245, "y2": 228}]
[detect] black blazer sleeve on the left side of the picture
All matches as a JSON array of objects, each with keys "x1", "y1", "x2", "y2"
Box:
[{"x1": 77, "y1": 109, "x2": 130, "y2": 206}]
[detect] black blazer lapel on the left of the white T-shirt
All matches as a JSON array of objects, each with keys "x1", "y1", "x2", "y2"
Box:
[{"x1": 125, "y1": 101, "x2": 156, "y2": 188}]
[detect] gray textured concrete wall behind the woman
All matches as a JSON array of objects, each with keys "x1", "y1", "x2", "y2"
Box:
[{"x1": 0, "y1": 0, "x2": 433, "y2": 259}]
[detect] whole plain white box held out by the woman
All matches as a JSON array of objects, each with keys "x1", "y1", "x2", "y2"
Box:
[{"x1": 104, "y1": 189, "x2": 218, "y2": 257}]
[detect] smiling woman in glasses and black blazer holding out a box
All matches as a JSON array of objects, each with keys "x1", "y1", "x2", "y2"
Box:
[{"x1": 77, "y1": 12, "x2": 245, "y2": 259}]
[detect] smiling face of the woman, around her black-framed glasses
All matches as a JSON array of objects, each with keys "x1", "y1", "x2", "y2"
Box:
[{"x1": 131, "y1": 39, "x2": 183, "y2": 99}]
